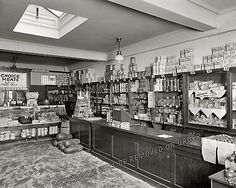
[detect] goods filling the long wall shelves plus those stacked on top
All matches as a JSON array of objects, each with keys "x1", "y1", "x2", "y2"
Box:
[{"x1": 74, "y1": 43, "x2": 236, "y2": 131}]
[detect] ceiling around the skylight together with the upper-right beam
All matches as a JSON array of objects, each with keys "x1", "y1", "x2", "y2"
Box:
[{"x1": 0, "y1": 0, "x2": 236, "y2": 61}]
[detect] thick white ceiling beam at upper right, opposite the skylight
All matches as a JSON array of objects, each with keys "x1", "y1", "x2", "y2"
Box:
[{"x1": 108, "y1": 0, "x2": 218, "y2": 31}]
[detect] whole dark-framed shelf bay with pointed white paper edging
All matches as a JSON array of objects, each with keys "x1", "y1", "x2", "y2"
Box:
[{"x1": 188, "y1": 71, "x2": 228, "y2": 128}]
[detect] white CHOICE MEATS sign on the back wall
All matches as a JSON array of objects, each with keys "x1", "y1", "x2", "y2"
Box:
[{"x1": 0, "y1": 72, "x2": 27, "y2": 90}]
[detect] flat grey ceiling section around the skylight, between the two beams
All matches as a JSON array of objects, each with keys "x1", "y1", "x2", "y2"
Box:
[{"x1": 0, "y1": 0, "x2": 184, "y2": 52}]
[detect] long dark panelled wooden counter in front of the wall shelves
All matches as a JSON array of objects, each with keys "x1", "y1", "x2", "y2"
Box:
[{"x1": 71, "y1": 119, "x2": 223, "y2": 188}]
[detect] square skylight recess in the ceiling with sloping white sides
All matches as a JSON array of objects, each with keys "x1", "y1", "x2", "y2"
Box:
[{"x1": 13, "y1": 4, "x2": 88, "y2": 39}]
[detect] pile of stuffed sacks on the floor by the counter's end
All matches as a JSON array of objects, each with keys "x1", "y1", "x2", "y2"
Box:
[{"x1": 52, "y1": 133, "x2": 83, "y2": 153}]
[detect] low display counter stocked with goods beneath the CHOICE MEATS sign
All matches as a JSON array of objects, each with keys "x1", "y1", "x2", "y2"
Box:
[{"x1": 0, "y1": 105, "x2": 65, "y2": 144}]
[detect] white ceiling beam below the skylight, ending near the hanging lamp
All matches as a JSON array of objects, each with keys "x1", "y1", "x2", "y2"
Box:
[{"x1": 0, "y1": 38, "x2": 108, "y2": 61}]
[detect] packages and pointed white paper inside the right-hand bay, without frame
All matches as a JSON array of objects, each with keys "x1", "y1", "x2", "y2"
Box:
[{"x1": 189, "y1": 77, "x2": 227, "y2": 127}]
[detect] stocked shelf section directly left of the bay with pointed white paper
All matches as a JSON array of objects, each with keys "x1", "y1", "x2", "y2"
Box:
[{"x1": 152, "y1": 75, "x2": 183, "y2": 127}]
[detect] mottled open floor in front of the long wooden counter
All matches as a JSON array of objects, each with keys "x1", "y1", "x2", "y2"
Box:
[{"x1": 0, "y1": 141, "x2": 164, "y2": 188}]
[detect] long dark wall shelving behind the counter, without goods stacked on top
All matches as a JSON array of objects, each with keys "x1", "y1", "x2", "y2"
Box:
[{"x1": 74, "y1": 65, "x2": 236, "y2": 136}]
